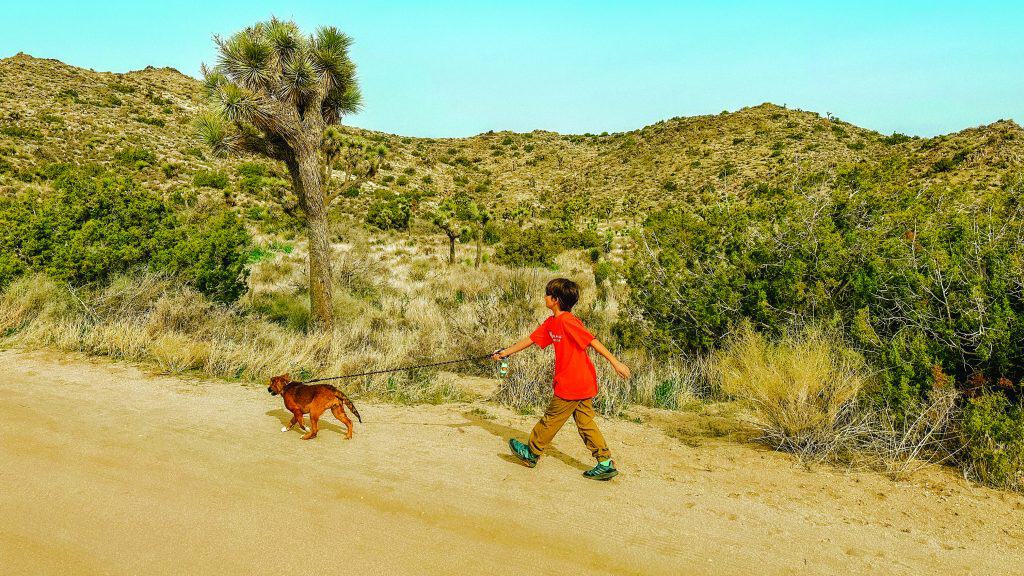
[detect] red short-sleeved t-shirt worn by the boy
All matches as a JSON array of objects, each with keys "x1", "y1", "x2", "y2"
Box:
[{"x1": 529, "y1": 312, "x2": 597, "y2": 400}]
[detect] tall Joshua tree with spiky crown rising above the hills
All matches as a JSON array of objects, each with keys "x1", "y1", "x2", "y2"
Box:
[{"x1": 197, "y1": 18, "x2": 385, "y2": 331}]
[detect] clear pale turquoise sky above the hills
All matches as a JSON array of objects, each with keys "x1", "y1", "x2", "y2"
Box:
[{"x1": 0, "y1": 0, "x2": 1024, "y2": 136}]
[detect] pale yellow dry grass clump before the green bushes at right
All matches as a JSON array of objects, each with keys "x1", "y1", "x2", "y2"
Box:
[{"x1": 711, "y1": 328, "x2": 869, "y2": 458}]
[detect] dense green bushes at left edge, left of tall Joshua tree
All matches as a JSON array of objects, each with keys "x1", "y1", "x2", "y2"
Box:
[{"x1": 0, "y1": 167, "x2": 250, "y2": 301}]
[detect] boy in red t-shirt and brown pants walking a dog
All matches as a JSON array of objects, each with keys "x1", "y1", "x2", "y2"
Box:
[{"x1": 492, "y1": 278, "x2": 630, "y2": 480}]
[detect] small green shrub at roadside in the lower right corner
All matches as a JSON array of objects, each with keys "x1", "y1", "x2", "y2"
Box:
[{"x1": 961, "y1": 392, "x2": 1024, "y2": 490}]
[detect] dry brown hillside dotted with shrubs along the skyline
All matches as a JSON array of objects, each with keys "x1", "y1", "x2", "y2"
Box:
[{"x1": 0, "y1": 53, "x2": 1024, "y2": 221}]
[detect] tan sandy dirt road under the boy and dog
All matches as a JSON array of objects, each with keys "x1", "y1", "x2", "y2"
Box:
[{"x1": 0, "y1": 351, "x2": 1024, "y2": 576}]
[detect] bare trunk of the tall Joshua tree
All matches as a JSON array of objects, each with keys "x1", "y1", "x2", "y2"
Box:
[{"x1": 289, "y1": 149, "x2": 334, "y2": 332}]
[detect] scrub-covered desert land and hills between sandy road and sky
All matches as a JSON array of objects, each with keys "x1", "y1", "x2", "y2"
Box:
[{"x1": 0, "y1": 55, "x2": 1024, "y2": 489}]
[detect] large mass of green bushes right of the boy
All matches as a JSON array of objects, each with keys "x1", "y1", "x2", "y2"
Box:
[{"x1": 620, "y1": 156, "x2": 1024, "y2": 401}]
